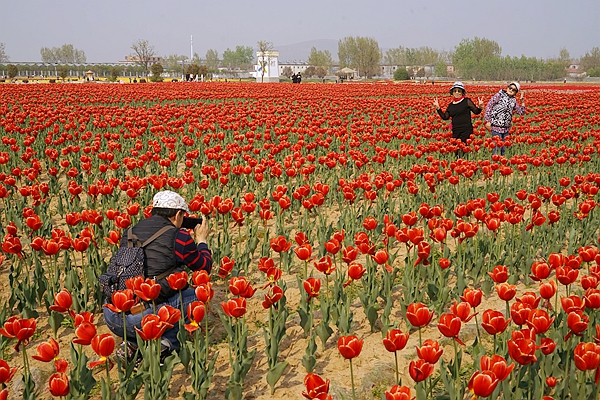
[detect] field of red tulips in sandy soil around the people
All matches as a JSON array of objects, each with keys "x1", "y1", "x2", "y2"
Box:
[{"x1": 0, "y1": 82, "x2": 600, "y2": 400}]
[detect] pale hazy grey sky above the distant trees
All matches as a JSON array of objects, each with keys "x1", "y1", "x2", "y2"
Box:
[{"x1": 0, "y1": 0, "x2": 600, "y2": 62}]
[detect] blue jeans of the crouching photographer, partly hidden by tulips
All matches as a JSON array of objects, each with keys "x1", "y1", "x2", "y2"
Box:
[{"x1": 103, "y1": 289, "x2": 198, "y2": 350}]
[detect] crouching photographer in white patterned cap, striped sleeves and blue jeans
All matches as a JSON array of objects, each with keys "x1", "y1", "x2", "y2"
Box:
[{"x1": 104, "y1": 190, "x2": 212, "y2": 361}]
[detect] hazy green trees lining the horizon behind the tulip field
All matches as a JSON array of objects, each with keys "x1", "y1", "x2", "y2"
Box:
[{"x1": 0, "y1": 36, "x2": 600, "y2": 80}]
